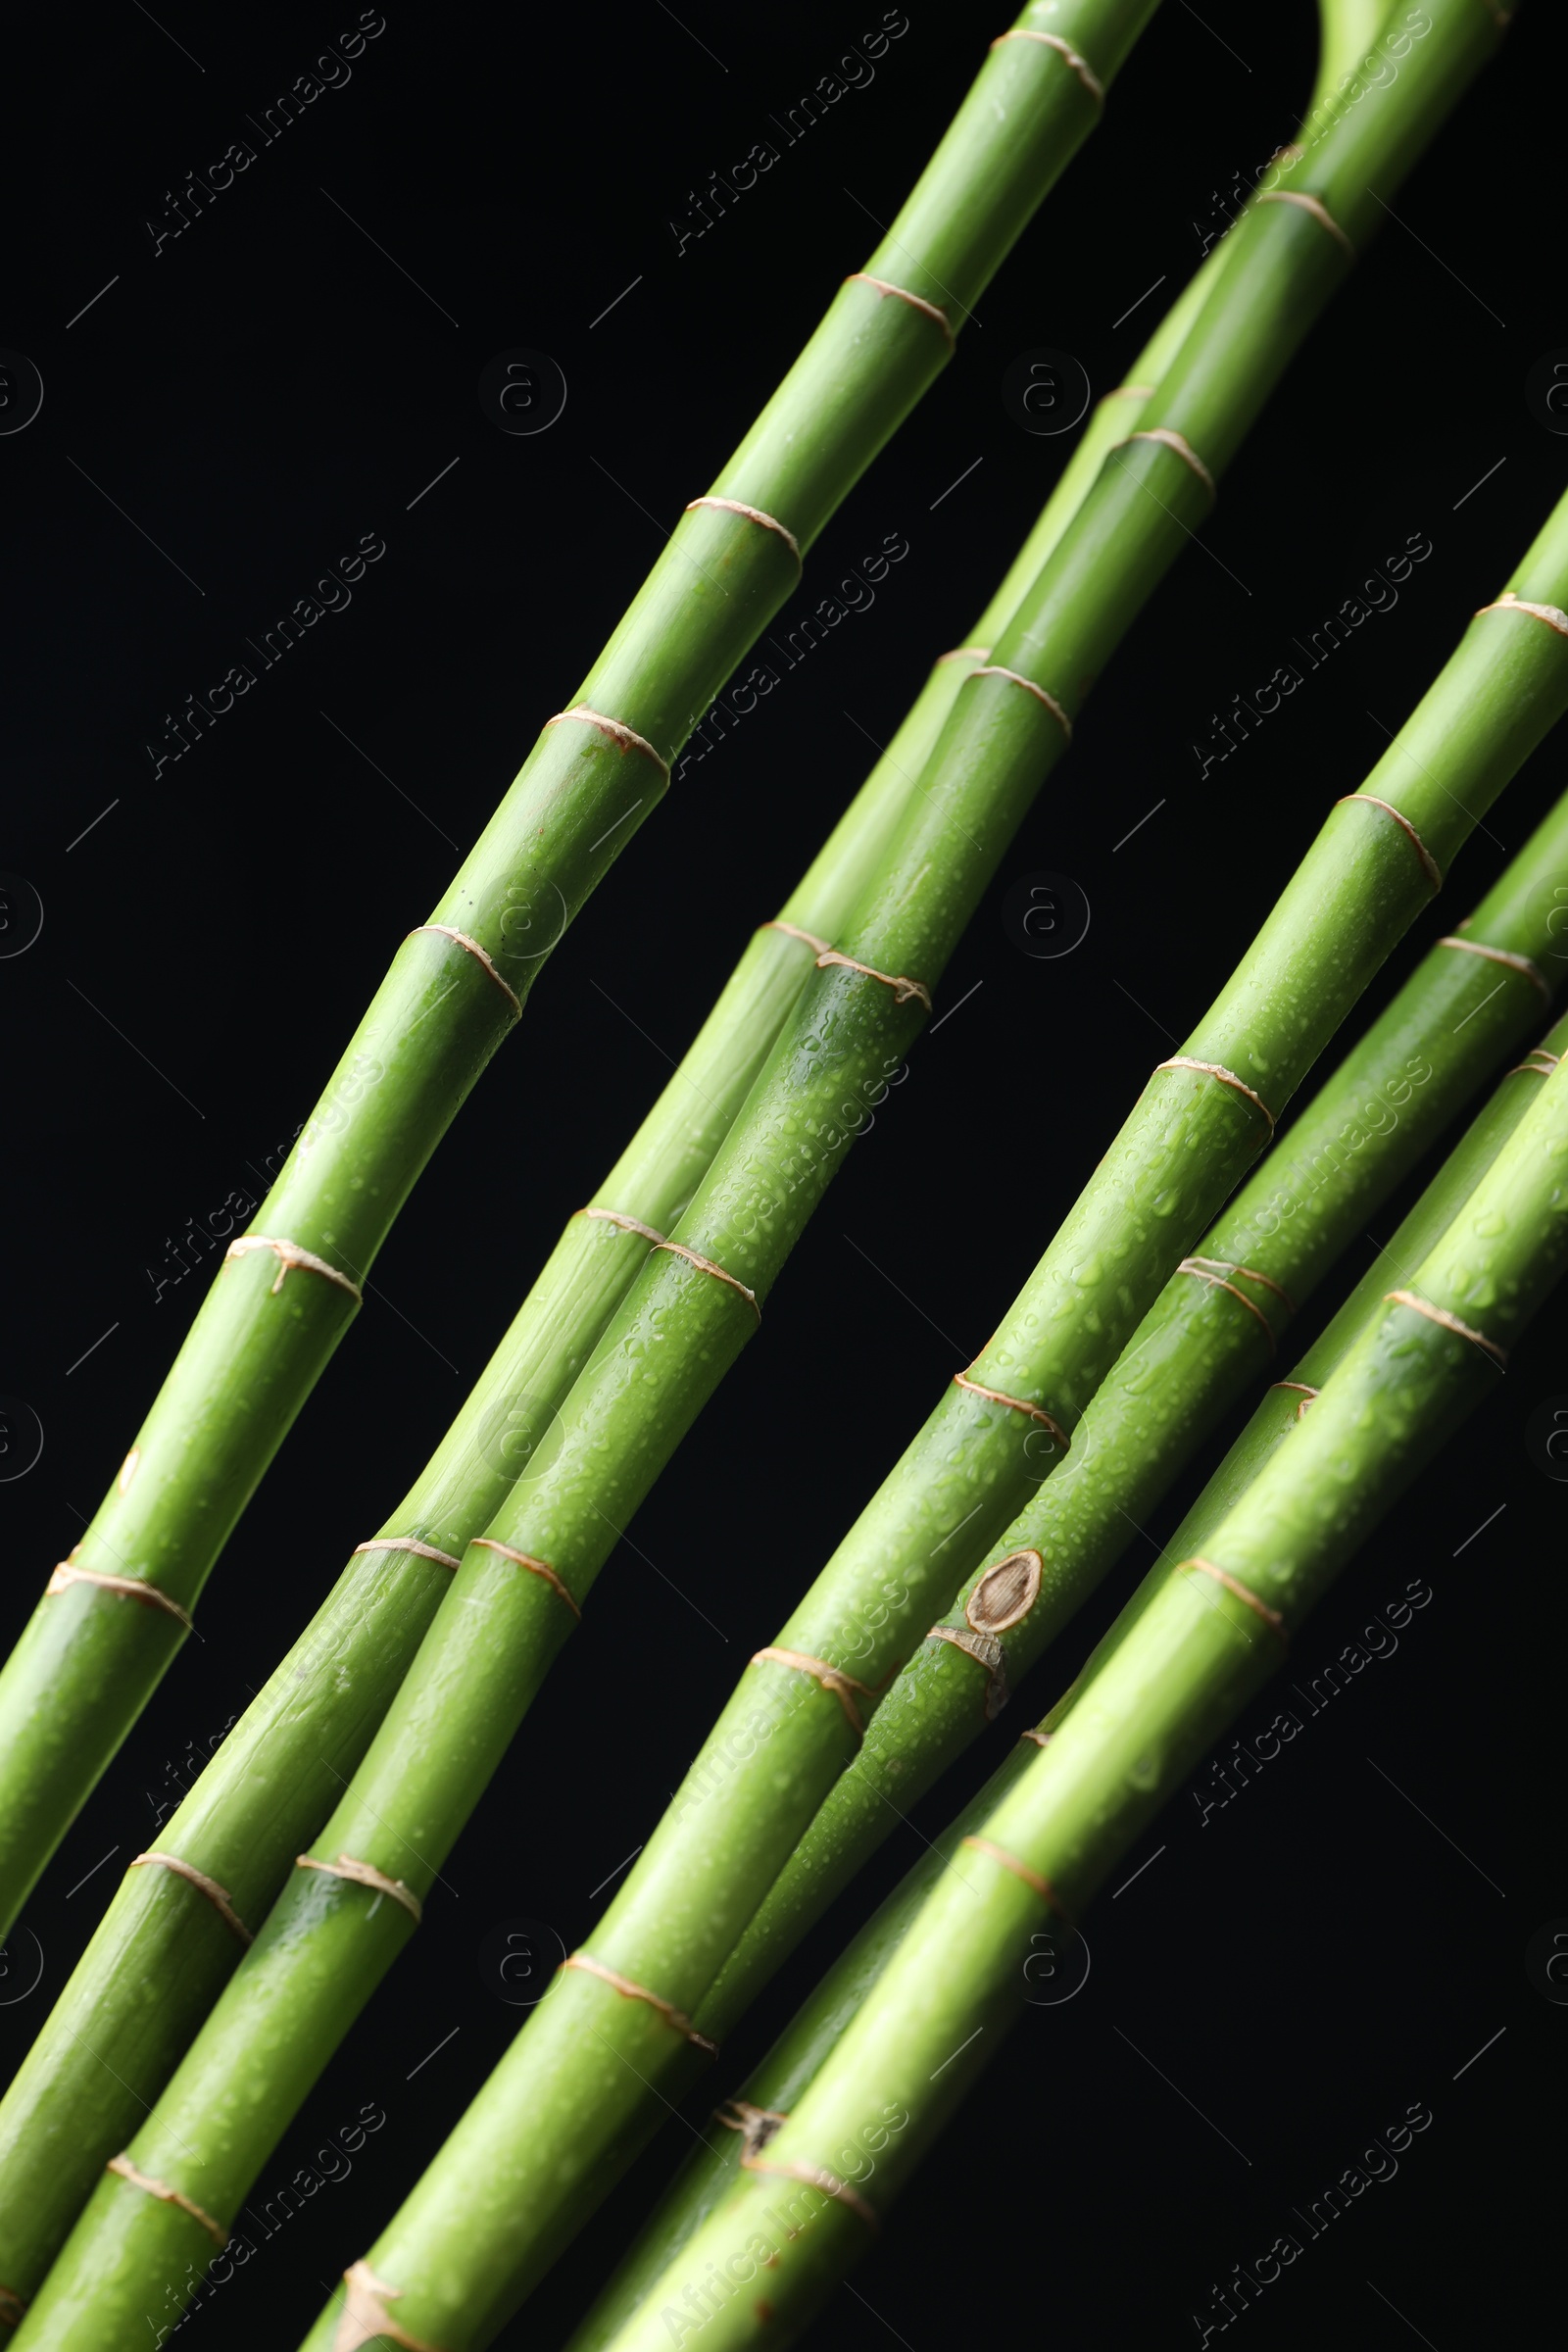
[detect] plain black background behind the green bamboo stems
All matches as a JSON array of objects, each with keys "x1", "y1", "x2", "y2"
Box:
[{"x1": 0, "y1": 0, "x2": 1568, "y2": 2352}]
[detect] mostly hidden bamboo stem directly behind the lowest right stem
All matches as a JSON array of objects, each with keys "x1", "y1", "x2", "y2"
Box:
[{"x1": 566, "y1": 992, "x2": 1568, "y2": 2352}]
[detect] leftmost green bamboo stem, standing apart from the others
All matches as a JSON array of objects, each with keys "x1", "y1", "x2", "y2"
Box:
[{"x1": 0, "y1": 0, "x2": 1156, "y2": 1936}]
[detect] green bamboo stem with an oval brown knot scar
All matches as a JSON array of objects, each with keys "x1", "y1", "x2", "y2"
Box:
[{"x1": 696, "y1": 771, "x2": 1568, "y2": 2039}]
